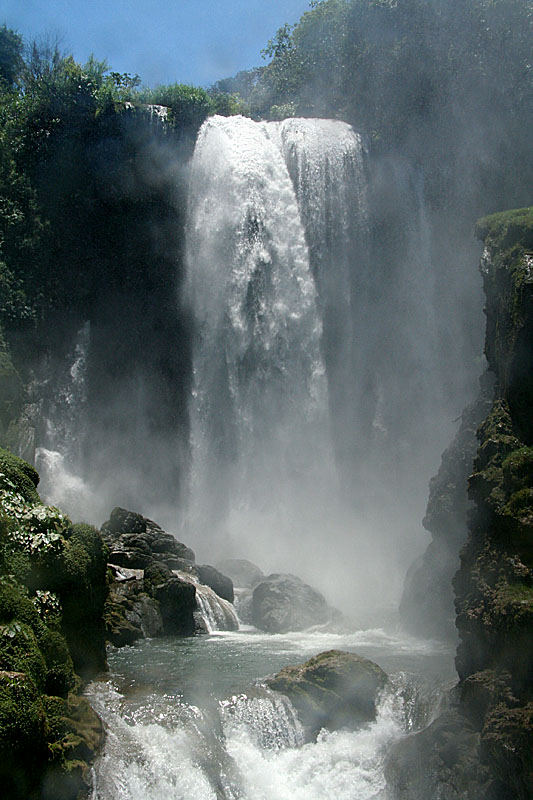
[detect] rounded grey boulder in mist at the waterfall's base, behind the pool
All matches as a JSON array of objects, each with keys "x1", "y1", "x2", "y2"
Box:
[{"x1": 251, "y1": 573, "x2": 331, "y2": 633}]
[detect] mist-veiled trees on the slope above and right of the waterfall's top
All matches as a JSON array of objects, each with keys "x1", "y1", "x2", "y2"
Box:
[{"x1": 249, "y1": 0, "x2": 533, "y2": 211}]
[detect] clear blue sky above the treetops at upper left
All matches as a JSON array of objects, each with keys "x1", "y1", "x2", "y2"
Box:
[{"x1": 0, "y1": 0, "x2": 309, "y2": 86}]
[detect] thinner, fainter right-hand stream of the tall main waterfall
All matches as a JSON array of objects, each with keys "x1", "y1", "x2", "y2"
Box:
[{"x1": 272, "y1": 119, "x2": 368, "y2": 482}]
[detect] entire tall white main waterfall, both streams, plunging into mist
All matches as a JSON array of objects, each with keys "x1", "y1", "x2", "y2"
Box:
[{"x1": 186, "y1": 116, "x2": 365, "y2": 572}]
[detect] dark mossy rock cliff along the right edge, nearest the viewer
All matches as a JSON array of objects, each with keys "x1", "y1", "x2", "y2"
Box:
[{"x1": 388, "y1": 208, "x2": 533, "y2": 800}]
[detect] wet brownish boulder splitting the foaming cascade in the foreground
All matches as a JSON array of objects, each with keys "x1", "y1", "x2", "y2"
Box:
[{"x1": 266, "y1": 650, "x2": 388, "y2": 738}]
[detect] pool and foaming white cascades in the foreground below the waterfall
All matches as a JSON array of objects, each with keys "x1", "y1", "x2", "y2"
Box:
[{"x1": 89, "y1": 629, "x2": 452, "y2": 800}]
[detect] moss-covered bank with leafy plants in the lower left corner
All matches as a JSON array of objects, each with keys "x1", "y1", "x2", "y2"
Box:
[{"x1": 0, "y1": 449, "x2": 107, "y2": 800}]
